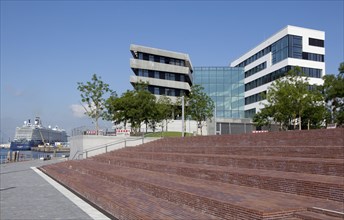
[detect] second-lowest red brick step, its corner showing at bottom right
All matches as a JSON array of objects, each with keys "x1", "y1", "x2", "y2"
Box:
[{"x1": 45, "y1": 160, "x2": 342, "y2": 219}]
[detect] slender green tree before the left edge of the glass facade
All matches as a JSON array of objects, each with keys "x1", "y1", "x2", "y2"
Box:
[{"x1": 184, "y1": 85, "x2": 215, "y2": 135}]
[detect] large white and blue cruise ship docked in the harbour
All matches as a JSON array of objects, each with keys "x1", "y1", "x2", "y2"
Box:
[{"x1": 10, "y1": 117, "x2": 68, "y2": 151}]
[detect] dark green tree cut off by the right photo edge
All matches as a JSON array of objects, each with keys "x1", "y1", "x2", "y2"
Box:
[{"x1": 322, "y1": 62, "x2": 344, "y2": 126}]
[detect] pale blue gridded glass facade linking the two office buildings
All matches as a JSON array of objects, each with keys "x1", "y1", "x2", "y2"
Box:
[{"x1": 193, "y1": 67, "x2": 245, "y2": 119}]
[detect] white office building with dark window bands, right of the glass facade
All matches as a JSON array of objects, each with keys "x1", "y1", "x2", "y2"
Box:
[{"x1": 230, "y1": 26, "x2": 325, "y2": 118}]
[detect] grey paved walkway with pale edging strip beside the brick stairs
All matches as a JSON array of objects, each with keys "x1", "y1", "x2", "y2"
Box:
[{"x1": 0, "y1": 159, "x2": 108, "y2": 220}]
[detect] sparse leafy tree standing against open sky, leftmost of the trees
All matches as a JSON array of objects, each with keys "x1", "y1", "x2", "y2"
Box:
[{"x1": 77, "y1": 74, "x2": 116, "y2": 134}]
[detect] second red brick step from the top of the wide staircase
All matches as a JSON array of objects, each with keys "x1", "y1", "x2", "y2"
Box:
[{"x1": 125, "y1": 143, "x2": 344, "y2": 159}]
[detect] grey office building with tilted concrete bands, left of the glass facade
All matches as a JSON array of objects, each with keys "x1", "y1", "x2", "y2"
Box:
[{"x1": 130, "y1": 44, "x2": 193, "y2": 101}]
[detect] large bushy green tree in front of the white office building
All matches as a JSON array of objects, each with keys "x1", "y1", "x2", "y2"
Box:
[{"x1": 255, "y1": 67, "x2": 324, "y2": 130}]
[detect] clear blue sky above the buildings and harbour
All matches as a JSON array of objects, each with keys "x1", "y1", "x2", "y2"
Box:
[{"x1": 0, "y1": 0, "x2": 344, "y2": 142}]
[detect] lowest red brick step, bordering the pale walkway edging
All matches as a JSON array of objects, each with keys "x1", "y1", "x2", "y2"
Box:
[{"x1": 43, "y1": 165, "x2": 219, "y2": 220}]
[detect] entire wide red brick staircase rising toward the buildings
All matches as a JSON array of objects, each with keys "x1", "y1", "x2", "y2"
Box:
[{"x1": 41, "y1": 128, "x2": 344, "y2": 220}]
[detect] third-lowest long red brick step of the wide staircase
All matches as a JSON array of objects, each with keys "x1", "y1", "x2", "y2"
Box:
[{"x1": 92, "y1": 154, "x2": 344, "y2": 201}]
